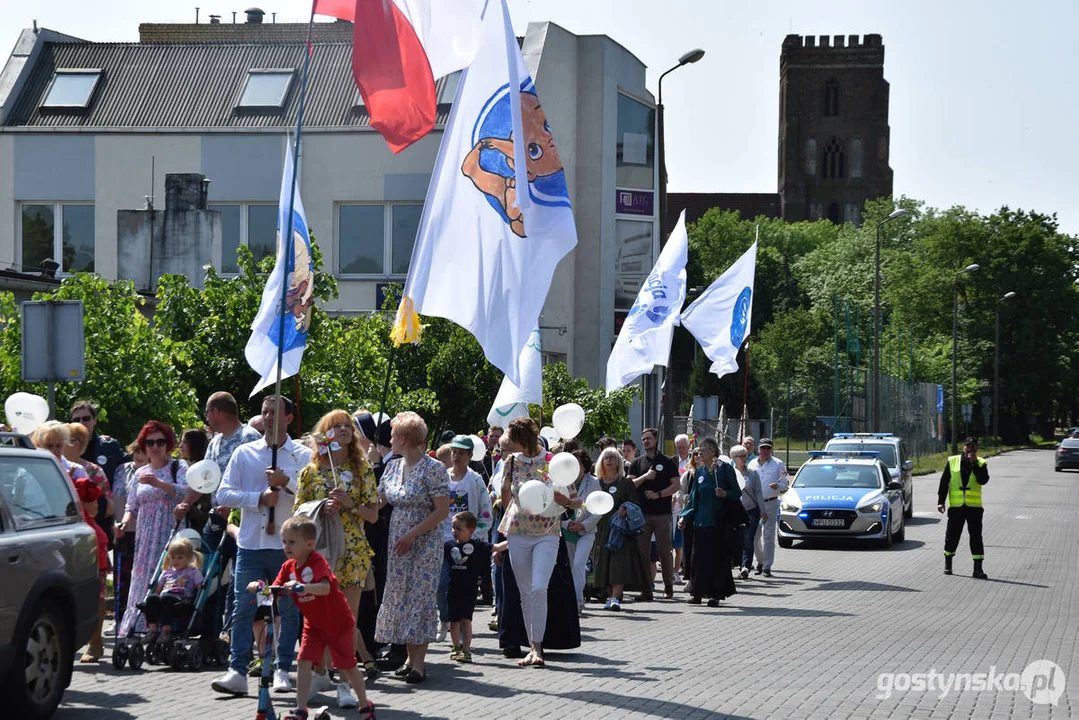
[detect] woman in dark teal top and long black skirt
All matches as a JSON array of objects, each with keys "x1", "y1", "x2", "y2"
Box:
[{"x1": 679, "y1": 437, "x2": 741, "y2": 608}]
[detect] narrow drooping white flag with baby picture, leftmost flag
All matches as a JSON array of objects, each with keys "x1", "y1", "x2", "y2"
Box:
[{"x1": 244, "y1": 141, "x2": 315, "y2": 396}]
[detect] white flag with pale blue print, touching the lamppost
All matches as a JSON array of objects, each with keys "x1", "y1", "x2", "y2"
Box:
[{"x1": 606, "y1": 210, "x2": 689, "y2": 393}]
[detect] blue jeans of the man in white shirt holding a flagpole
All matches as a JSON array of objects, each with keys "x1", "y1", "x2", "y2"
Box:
[{"x1": 229, "y1": 548, "x2": 300, "y2": 675}]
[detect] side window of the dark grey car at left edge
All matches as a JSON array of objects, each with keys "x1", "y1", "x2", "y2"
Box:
[{"x1": 0, "y1": 456, "x2": 80, "y2": 530}]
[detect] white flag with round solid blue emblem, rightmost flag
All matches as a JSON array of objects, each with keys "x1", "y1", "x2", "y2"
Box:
[{"x1": 682, "y1": 242, "x2": 756, "y2": 378}]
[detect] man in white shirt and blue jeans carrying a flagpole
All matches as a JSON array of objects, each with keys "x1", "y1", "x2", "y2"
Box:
[{"x1": 211, "y1": 396, "x2": 311, "y2": 695}]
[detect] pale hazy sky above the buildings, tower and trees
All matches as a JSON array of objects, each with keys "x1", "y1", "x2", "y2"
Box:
[{"x1": 6, "y1": 0, "x2": 1079, "y2": 235}]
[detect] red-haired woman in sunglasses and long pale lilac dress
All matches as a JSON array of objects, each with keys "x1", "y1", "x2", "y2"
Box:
[{"x1": 117, "y1": 420, "x2": 188, "y2": 637}]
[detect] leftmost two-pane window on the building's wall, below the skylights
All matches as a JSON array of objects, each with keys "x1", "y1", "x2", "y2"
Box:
[{"x1": 21, "y1": 203, "x2": 94, "y2": 273}]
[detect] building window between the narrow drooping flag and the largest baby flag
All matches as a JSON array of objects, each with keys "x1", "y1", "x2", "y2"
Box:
[{"x1": 338, "y1": 203, "x2": 423, "y2": 275}]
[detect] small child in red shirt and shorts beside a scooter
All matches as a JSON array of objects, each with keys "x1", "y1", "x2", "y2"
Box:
[{"x1": 248, "y1": 515, "x2": 374, "y2": 720}]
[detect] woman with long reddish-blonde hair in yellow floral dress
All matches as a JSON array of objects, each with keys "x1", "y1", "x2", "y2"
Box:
[{"x1": 295, "y1": 410, "x2": 379, "y2": 674}]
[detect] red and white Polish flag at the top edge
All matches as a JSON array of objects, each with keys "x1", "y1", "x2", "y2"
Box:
[{"x1": 314, "y1": 0, "x2": 480, "y2": 153}]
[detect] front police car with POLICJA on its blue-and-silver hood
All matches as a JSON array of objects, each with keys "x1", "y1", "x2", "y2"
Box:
[{"x1": 777, "y1": 450, "x2": 906, "y2": 547}]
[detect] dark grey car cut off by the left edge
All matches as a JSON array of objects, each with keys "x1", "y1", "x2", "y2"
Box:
[{"x1": 0, "y1": 441, "x2": 100, "y2": 718}]
